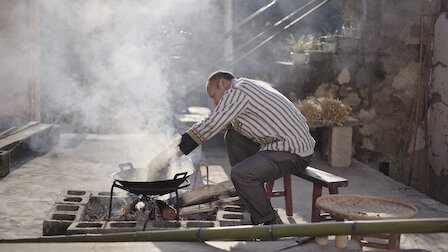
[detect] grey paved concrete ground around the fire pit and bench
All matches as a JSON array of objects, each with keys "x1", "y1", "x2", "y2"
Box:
[{"x1": 0, "y1": 134, "x2": 448, "y2": 251}]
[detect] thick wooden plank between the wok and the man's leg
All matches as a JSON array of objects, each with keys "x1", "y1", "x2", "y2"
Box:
[{"x1": 181, "y1": 180, "x2": 235, "y2": 206}]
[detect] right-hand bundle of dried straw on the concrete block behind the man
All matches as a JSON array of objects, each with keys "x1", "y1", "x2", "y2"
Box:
[{"x1": 319, "y1": 98, "x2": 350, "y2": 126}]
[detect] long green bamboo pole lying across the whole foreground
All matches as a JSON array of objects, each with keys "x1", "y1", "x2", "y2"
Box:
[{"x1": 0, "y1": 218, "x2": 448, "y2": 243}]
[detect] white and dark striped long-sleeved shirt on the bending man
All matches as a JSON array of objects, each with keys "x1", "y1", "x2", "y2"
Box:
[{"x1": 187, "y1": 78, "x2": 316, "y2": 157}]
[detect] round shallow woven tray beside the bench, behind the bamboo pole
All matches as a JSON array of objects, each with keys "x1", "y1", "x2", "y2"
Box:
[{"x1": 316, "y1": 194, "x2": 418, "y2": 220}]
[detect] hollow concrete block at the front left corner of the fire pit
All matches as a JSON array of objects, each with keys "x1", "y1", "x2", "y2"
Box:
[{"x1": 42, "y1": 204, "x2": 85, "y2": 236}]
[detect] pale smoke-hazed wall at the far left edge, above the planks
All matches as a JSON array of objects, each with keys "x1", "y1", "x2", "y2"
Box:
[{"x1": 0, "y1": 0, "x2": 40, "y2": 126}]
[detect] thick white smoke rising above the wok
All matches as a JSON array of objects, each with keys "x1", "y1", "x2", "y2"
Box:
[{"x1": 40, "y1": 0, "x2": 222, "y2": 171}]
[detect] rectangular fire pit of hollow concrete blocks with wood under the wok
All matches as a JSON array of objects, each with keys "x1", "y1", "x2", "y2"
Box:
[{"x1": 43, "y1": 190, "x2": 251, "y2": 236}]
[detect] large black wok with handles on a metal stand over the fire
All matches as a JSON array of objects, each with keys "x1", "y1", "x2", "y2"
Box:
[{"x1": 109, "y1": 163, "x2": 190, "y2": 219}]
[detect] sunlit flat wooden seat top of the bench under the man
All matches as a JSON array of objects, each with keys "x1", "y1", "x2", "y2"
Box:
[{"x1": 295, "y1": 166, "x2": 348, "y2": 188}]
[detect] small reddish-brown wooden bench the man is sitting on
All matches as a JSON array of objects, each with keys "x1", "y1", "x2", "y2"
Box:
[{"x1": 266, "y1": 166, "x2": 348, "y2": 222}]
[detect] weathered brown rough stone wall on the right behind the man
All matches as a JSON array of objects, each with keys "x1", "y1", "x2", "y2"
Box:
[{"x1": 282, "y1": 0, "x2": 448, "y2": 203}]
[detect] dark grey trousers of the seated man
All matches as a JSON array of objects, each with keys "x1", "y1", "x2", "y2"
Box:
[{"x1": 224, "y1": 130, "x2": 312, "y2": 225}]
